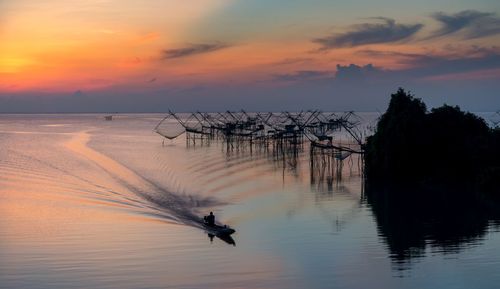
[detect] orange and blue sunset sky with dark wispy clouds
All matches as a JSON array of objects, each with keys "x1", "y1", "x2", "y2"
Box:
[{"x1": 0, "y1": 0, "x2": 500, "y2": 112}]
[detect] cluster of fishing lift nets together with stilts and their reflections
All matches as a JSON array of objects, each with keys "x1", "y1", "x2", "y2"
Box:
[{"x1": 155, "y1": 110, "x2": 365, "y2": 183}]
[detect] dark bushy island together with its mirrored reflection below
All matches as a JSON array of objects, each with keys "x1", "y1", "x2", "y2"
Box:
[{"x1": 365, "y1": 89, "x2": 500, "y2": 270}]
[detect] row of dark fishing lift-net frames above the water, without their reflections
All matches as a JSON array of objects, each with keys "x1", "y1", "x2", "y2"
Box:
[{"x1": 154, "y1": 110, "x2": 367, "y2": 149}]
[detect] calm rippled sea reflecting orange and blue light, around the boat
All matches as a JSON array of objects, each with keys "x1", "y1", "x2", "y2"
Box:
[{"x1": 0, "y1": 114, "x2": 500, "y2": 289}]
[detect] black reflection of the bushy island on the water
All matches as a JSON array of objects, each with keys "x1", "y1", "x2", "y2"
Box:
[{"x1": 365, "y1": 188, "x2": 500, "y2": 269}]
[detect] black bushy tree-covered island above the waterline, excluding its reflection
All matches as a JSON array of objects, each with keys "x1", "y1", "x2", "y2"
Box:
[{"x1": 365, "y1": 88, "x2": 500, "y2": 199}]
